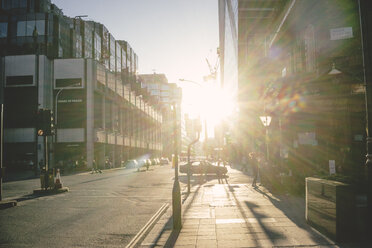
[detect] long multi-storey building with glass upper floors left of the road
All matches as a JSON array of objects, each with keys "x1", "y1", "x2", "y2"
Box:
[{"x1": 0, "y1": 0, "x2": 162, "y2": 172}]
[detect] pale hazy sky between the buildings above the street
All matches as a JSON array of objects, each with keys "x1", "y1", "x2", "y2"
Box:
[{"x1": 52, "y1": 0, "x2": 218, "y2": 82}]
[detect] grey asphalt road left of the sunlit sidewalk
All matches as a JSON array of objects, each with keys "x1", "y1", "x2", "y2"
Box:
[{"x1": 0, "y1": 165, "x2": 174, "y2": 247}]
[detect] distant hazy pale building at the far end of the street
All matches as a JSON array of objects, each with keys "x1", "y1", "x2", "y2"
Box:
[{"x1": 139, "y1": 73, "x2": 183, "y2": 158}]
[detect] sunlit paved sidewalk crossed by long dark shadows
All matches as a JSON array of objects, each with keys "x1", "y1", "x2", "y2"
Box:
[{"x1": 140, "y1": 168, "x2": 360, "y2": 248}]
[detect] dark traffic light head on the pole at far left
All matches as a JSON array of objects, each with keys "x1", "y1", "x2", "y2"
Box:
[{"x1": 36, "y1": 109, "x2": 55, "y2": 136}]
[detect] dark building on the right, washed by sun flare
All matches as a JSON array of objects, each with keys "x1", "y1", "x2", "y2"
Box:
[{"x1": 220, "y1": 0, "x2": 366, "y2": 186}]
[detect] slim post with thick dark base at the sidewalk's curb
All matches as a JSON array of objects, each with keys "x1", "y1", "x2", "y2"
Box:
[{"x1": 172, "y1": 102, "x2": 182, "y2": 230}]
